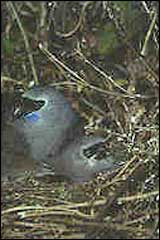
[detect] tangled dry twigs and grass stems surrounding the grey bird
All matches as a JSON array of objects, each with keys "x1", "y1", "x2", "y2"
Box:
[{"x1": 1, "y1": 1, "x2": 159, "y2": 239}]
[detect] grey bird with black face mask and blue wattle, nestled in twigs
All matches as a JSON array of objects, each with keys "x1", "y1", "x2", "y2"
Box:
[{"x1": 1, "y1": 86, "x2": 117, "y2": 182}]
